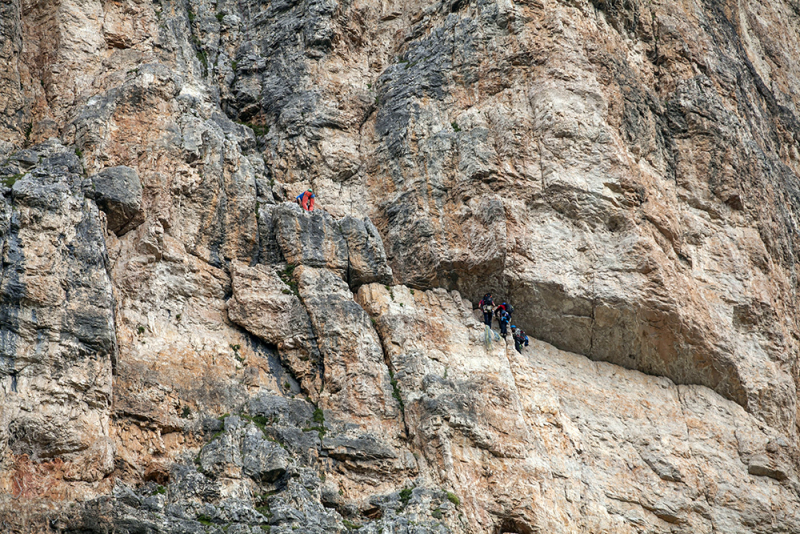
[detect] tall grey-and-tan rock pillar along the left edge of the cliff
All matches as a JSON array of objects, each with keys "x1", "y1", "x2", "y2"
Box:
[{"x1": 0, "y1": 154, "x2": 117, "y2": 481}]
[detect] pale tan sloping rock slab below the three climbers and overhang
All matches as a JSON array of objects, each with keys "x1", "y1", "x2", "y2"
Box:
[{"x1": 358, "y1": 285, "x2": 800, "y2": 532}]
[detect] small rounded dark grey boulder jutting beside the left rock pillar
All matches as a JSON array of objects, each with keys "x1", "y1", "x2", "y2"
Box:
[{"x1": 91, "y1": 166, "x2": 144, "y2": 235}]
